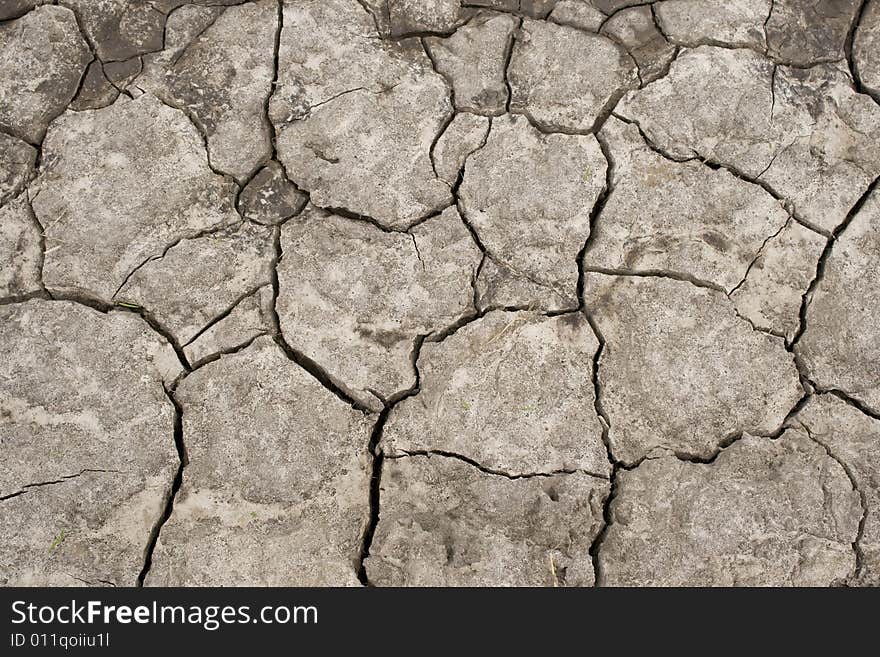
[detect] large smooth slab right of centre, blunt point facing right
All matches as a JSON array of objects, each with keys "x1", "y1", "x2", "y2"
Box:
[{"x1": 584, "y1": 273, "x2": 803, "y2": 463}]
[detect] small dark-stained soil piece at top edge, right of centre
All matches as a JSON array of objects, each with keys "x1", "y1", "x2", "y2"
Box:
[{"x1": 602, "y1": 6, "x2": 675, "y2": 82}]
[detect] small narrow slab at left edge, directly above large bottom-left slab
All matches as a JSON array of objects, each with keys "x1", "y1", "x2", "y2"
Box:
[{"x1": 0, "y1": 197, "x2": 43, "y2": 297}]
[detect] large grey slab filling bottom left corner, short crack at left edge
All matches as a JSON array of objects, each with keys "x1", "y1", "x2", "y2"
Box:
[{"x1": 0, "y1": 301, "x2": 179, "y2": 586}]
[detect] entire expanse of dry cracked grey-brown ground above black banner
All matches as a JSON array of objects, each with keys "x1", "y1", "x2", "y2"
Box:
[{"x1": 0, "y1": 0, "x2": 880, "y2": 586}]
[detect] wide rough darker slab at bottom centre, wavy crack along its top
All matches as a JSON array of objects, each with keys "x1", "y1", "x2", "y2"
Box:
[{"x1": 366, "y1": 456, "x2": 609, "y2": 586}]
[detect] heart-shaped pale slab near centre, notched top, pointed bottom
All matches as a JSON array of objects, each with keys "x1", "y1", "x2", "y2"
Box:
[{"x1": 277, "y1": 208, "x2": 481, "y2": 410}]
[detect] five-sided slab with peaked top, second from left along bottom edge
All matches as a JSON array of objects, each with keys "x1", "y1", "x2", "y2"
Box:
[{"x1": 146, "y1": 338, "x2": 370, "y2": 586}]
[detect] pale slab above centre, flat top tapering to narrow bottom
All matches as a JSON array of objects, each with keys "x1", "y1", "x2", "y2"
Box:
[{"x1": 459, "y1": 115, "x2": 607, "y2": 307}]
